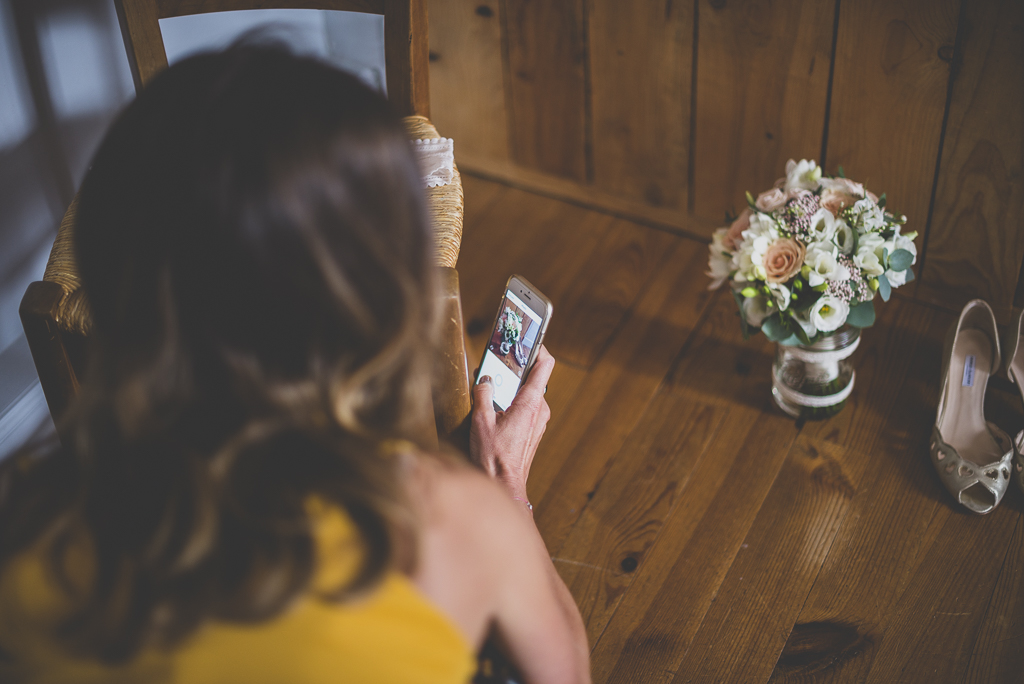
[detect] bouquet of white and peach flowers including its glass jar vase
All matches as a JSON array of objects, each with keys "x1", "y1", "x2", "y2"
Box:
[{"x1": 708, "y1": 160, "x2": 918, "y2": 418}]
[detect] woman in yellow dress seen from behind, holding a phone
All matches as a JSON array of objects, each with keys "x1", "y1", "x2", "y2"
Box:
[{"x1": 0, "y1": 45, "x2": 589, "y2": 684}]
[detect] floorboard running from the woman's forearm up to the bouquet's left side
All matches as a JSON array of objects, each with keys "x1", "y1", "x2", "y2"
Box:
[{"x1": 529, "y1": 241, "x2": 720, "y2": 549}]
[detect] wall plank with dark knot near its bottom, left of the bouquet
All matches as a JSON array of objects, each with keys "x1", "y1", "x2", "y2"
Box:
[{"x1": 587, "y1": 0, "x2": 693, "y2": 211}]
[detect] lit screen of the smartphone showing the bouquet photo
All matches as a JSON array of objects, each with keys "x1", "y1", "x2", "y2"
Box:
[{"x1": 477, "y1": 290, "x2": 542, "y2": 411}]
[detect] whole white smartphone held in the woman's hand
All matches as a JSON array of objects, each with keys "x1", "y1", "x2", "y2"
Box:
[{"x1": 474, "y1": 275, "x2": 552, "y2": 411}]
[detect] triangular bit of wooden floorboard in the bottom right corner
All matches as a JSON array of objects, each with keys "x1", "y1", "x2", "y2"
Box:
[{"x1": 964, "y1": 520, "x2": 1024, "y2": 684}]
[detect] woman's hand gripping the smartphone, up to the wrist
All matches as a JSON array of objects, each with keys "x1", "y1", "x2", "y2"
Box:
[{"x1": 469, "y1": 345, "x2": 555, "y2": 501}]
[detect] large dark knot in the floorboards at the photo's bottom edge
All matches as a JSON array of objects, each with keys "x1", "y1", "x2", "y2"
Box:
[{"x1": 772, "y1": 622, "x2": 873, "y2": 678}]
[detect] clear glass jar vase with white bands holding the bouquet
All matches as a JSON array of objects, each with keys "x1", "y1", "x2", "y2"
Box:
[{"x1": 771, "y1": 326, "x2": 860, "y2": 420}]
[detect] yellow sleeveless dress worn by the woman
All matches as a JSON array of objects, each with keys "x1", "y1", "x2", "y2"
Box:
[{"x1": 0, "y1": 505, "x2": 475, "y2": 684}]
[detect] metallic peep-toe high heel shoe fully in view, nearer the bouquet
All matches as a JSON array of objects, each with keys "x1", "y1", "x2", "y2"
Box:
[{"x1": 931, "y1": 299, "x2": 1011, "y2": 513}]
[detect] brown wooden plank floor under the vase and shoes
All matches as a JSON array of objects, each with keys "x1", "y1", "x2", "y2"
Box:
[{"x1": 459, "y1": 177, "x2": 1024, "y2": 684}]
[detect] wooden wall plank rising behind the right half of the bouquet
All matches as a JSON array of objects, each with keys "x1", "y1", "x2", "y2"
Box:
[{"x1": 826, "y1": 0, "x2": 961, "y2": 259}]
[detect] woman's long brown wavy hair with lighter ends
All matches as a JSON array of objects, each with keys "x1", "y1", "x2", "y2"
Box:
[{"x1": 0, "y1": 44, "x2": 436, "y2": 662}]
